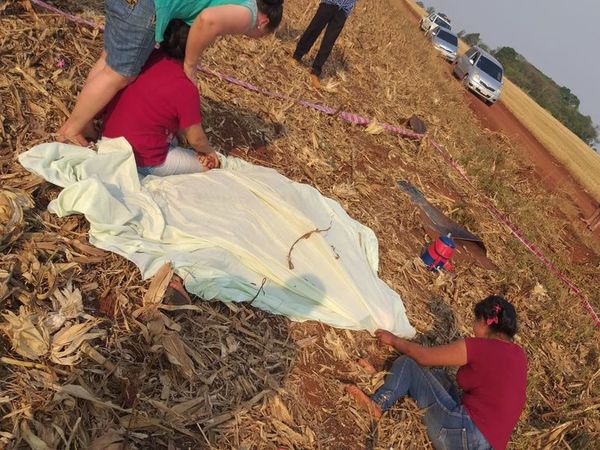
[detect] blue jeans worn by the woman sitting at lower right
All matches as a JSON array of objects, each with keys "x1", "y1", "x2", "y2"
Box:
[{"x1": 371, "y1": 356, "x2": 491, "y2": 450}]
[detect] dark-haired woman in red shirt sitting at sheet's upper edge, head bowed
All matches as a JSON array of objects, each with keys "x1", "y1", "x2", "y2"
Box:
[{"x1": 102, "y1": 19, "x2": 219, "y2": 176}]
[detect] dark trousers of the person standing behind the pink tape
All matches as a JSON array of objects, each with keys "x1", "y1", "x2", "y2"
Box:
[{"x1": 294, "y1": 3, "x2": 346, "y2": 76}]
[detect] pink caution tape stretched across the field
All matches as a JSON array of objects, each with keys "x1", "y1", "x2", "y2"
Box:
[{"x1": 30, "y1": 0, "x2": 600, "y2": 328}]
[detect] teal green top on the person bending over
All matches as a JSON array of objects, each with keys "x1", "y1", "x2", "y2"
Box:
[{"x1": 154, "y1": 0, "x2": 257, "y2": 42}]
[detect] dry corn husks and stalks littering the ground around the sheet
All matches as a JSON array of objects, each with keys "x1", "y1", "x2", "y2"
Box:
[{"x1": 0, "y1": 0, "x2": 600, "y2": 449}]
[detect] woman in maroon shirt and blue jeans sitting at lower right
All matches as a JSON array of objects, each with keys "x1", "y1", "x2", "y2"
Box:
[{"x1": 346, "y1": 296, "x2": 527, "y2": 450}]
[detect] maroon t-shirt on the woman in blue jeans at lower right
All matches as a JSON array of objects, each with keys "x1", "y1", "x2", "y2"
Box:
[{"x1": 456, "y1": 338, "x2": 527, "y2": 450}]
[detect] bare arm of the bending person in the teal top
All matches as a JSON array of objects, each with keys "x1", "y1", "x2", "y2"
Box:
[{"x1": 184, "y1": 5, "x2": 252, "y2": 81}]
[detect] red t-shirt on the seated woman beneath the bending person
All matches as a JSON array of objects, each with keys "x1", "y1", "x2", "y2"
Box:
[{"x1": 102, "y1": 50, "x2": 202, "y2": 166}]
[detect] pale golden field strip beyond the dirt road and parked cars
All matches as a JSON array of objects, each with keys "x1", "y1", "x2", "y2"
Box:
[{"x1": 402, "y1": 0, "x2": 600, "y2": 199}]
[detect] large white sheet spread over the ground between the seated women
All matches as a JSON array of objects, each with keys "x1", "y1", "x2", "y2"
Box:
[{"x1": 19, "y1": 138, "x2": 415, "y2": 337}]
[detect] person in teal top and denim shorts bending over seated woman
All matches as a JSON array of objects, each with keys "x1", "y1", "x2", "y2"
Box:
[{"x1": 58, "y1": 0, "x2": 283, "y2": 145}]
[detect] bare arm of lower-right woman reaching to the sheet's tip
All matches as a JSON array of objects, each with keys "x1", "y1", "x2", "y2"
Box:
[{"x1": 375, "y1": 330, "x2": 467, "y2": 366}]
